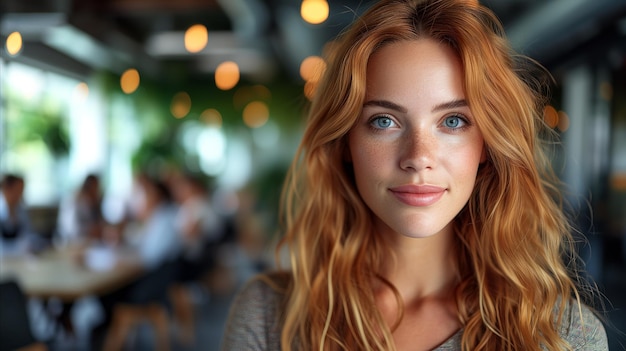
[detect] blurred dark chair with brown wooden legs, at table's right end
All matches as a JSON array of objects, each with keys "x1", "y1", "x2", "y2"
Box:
[{"x1": 103, "y1": 263, "x2": 175, "y2": 351}]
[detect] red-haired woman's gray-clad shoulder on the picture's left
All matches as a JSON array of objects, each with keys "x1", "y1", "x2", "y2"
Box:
[{"x1": 222, "y1": 275, "x2": 284, "y2": 350}]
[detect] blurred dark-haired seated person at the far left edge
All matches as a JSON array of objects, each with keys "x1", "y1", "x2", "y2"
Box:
[{"x1": 0, "y1": 174, "x2": 38, "y2": 255}]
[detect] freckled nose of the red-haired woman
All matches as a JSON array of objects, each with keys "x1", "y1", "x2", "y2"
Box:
[{"x1": 400, "y1": 131, "x2": 438, "y2": 172}]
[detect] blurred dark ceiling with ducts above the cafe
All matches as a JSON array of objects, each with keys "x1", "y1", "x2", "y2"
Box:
[{"x1": 0, "y1": 0, "x2": 626, "y2": 82}]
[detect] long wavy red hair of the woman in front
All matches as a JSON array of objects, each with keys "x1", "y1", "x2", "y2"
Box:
[{"x1": 272, "y1": 0, "x2": 578, "y2": 350}]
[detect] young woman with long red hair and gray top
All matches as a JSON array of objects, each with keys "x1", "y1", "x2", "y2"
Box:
[{"x1": 222, "y1": 0, "x2": 607, "y2": 350}]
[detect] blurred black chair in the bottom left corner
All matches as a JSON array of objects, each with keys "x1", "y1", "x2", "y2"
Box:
[{"x1": 0, "y1": 280, "x2": 48, "y2": 351}]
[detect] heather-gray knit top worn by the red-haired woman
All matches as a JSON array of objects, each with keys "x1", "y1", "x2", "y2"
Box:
[{"x1": 221, "y1": 279, "x2": 609, "y2": 351}]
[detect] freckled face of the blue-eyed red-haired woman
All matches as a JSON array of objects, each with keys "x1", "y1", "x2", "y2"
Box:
[{"x1": 348, "y1": 39, "x2": 485, "y2": 242}]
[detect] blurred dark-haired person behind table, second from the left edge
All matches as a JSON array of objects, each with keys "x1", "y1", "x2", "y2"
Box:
[{"x1": 58, "y1": 174, "x2": 104, "y2": 243}]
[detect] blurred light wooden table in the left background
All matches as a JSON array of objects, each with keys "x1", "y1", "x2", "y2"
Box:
[{"x1": 0, "y1": 248, "x2": 144, "y2": 303}]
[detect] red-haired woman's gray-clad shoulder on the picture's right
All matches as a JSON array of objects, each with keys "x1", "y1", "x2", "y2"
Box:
[{"x1": 559, "y1": 300, "x2": 609, "y2": 351}]
